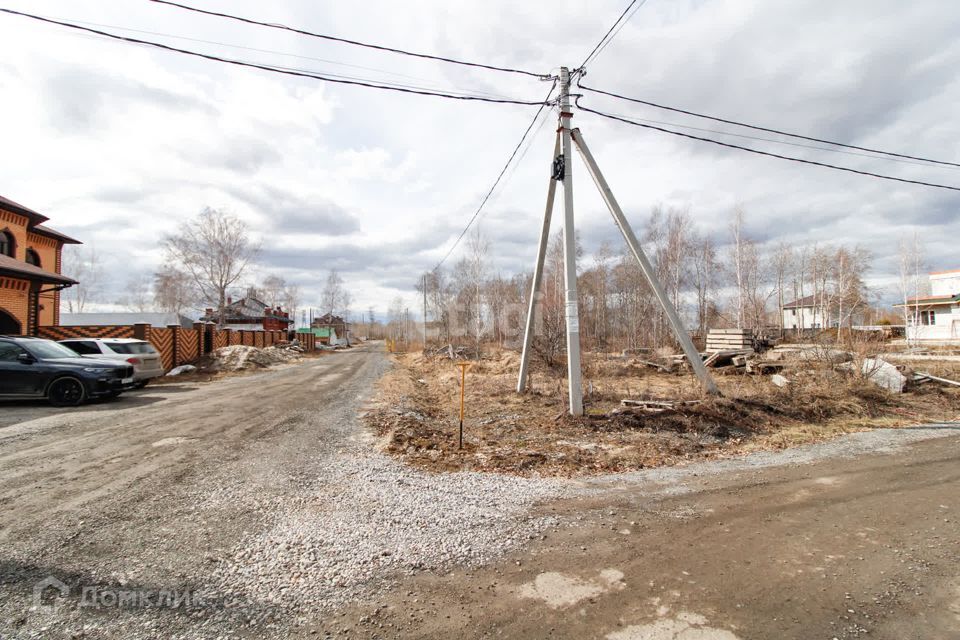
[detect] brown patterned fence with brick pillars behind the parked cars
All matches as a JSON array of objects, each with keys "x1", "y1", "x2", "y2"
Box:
[{"x1": 38, "y1": 322, "x2": 316, "y2": 370}]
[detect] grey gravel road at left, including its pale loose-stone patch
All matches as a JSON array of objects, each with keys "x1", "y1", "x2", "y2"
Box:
[{"x1": 0, "y1": 344, "x2": 562, "y2": 638}]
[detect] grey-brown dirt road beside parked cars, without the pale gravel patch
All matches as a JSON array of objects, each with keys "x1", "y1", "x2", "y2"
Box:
[{"x1": 0, "y1": 345, "x2": 398, "y2": 638}]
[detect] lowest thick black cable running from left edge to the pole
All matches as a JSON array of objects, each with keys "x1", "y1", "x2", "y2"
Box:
[{"x1": 0, "y1": 8, "x2": 546, "y2": 106}]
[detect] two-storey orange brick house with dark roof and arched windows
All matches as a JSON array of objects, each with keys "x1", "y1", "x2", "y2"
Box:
[{"x1": 0, "y1": 196, "x2": 80, "y2": 335}]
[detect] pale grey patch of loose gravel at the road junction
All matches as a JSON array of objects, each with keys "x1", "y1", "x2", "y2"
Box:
[{"x1": 204, "y1": 451, "x2": 563, "y2": 613}]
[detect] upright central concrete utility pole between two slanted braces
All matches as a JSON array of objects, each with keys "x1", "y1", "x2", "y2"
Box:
[{"x1": 560, "y1": 67, "x2": 583, "y2": 416}]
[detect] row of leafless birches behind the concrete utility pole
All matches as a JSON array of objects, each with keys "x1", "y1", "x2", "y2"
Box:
[{"x1": 406, "y1": 205, "x2": 871, "y2": 358}]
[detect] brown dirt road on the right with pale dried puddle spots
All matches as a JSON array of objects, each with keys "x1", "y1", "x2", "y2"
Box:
[{"x1": 330, "y1": 425, "x2": 960, "y2": 640}]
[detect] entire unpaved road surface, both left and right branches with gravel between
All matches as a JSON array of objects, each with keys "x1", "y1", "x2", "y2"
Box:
[{"x1": 0, "y1": 345, "x2": 960, "y2": 640}]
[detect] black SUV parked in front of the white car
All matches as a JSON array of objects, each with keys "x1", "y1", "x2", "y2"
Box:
[{"x1": 0, "y1": 336, "x2": 133, "y2": 407}]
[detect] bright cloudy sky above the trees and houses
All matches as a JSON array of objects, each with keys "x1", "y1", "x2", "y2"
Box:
[{"x1": 0, "y1": 0, "x2": 960, "y2": 320}]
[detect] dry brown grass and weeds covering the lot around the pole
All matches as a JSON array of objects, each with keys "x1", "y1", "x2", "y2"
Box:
[{"x1": 367, "y1": 344, "x2": 960, "y2": 476}]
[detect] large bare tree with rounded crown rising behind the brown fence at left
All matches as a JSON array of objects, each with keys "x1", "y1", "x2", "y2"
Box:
[{"x1": 163, "y1": 207, "x2": 259, "y2": 325}]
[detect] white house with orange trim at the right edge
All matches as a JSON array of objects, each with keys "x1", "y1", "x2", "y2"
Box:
[{"x1": 894, "y1": 269, "x2": 960, "y2": 343}]
